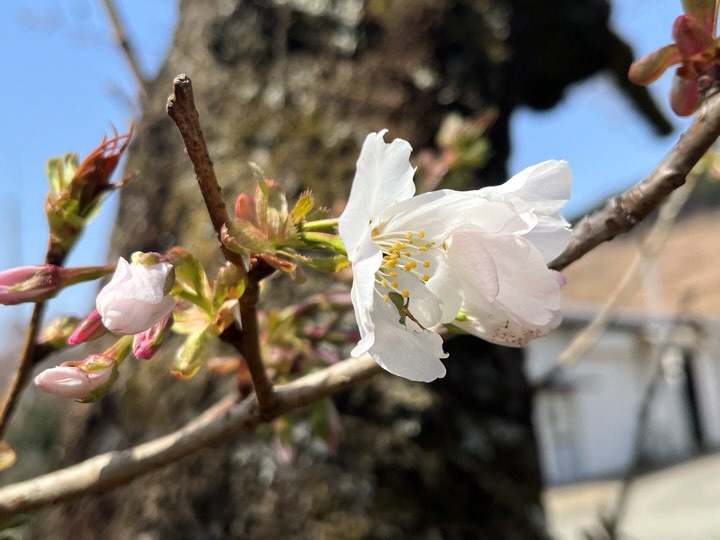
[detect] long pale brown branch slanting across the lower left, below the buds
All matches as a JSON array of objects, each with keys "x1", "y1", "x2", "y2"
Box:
[{"x1": 0, "y1": 356, "x2": 381, "y2": 517}]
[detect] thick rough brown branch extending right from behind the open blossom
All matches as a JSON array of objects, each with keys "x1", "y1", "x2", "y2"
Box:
[{"x1": 550, "y1": 86, "x2": 720, "y2": 270}]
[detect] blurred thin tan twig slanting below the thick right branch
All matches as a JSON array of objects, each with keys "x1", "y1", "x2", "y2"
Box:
[{"x1": 533, "y1": 175, "x2": 697, "y2": 390}]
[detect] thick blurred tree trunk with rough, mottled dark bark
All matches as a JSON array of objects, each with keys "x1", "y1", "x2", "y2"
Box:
[{"x1": 29, "y1": 0, "x2": 663, "y2": 539}]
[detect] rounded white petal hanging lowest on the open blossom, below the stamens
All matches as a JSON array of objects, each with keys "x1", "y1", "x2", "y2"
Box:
[{"x1": 370, "y1": 300, "x2": 447, "y2": 382}]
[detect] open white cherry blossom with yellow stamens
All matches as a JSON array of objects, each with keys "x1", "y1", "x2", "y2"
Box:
[{"x1": 339, "y1": 131, "x2": 572, "y2": 382}]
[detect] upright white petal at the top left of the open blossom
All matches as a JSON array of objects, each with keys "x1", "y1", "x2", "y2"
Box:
[{"x1": 339, "y1": 130, "x2": 415, "y2": 260}]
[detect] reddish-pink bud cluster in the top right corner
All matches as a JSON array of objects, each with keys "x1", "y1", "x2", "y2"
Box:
[{"x1": 628, "y1": 0, "x2": 720, "y2": 116}]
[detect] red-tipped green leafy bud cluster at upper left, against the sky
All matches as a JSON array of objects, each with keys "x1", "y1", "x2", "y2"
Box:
[{"x1": 45, "y1": 130, "x2": 132, "y2": 262}]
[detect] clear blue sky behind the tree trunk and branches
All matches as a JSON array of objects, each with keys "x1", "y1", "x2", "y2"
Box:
[{"x1": 0, "y1": 0, "x2": 687, "y2": 326}]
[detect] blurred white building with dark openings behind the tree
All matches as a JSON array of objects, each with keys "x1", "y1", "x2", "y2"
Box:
[{"x1": 527, "y1": 310, "x2": 720, "y2": 484}]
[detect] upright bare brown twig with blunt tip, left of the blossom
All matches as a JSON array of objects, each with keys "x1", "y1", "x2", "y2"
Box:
[{"x1": 166, "y1": 74, "x2": 245, "y2": 272}]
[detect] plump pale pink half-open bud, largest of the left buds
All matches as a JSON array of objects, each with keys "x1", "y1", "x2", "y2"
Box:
[{"x1": 95, "y1": 257, "x2": 175, "y2": 335}]
